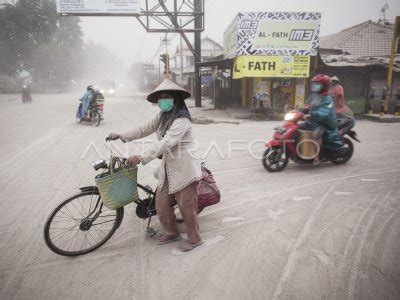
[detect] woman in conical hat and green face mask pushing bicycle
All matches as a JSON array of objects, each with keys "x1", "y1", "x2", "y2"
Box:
[{"x1": 108, "y1": 79, "x2": 202, "y2": 252}]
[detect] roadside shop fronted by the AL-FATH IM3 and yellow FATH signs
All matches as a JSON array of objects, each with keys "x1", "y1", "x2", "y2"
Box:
[{"x1": 201, "y1": 12, "x2": 321, "y2": 115}]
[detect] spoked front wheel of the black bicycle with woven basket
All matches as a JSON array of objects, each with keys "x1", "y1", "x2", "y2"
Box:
[{"x1": 44, "y1": 191, "x2": 124, "y2": 256}]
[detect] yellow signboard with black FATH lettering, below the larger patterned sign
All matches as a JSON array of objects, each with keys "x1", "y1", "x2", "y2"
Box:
[{"x1": 233, "y1": 56, "x2": 310, "y2": 79}]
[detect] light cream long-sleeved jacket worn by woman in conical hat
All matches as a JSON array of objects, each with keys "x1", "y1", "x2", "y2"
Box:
[{"x1": 121, "y1": 113, "x2": 202, "y2": 194}]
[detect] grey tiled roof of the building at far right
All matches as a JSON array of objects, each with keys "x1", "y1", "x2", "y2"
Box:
[{"x1": 320, "y1": 21, "x2": 393, "y2": 56}]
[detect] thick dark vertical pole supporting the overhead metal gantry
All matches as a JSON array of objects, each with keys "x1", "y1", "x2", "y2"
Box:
[{"x1": 193, "y1": 0, "x2": 203, "y2": 107}]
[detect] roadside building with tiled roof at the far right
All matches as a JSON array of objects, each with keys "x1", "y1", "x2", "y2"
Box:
[{"x1": 313, "y1": 21, "x2": 400, "y2": 114}]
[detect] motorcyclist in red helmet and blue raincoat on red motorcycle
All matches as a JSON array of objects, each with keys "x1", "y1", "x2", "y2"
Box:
[{"x1": 302, "y1": 74, "x2": 343, "y2": 164}]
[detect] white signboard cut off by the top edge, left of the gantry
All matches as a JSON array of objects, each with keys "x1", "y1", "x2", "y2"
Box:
[{"x1": 56, "y1": 0, "x2": 140, "y2": 15}]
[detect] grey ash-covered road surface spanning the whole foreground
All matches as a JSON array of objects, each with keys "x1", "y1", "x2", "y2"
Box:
[{"x1": 0, "y1": 94, "x2": 400, "y2": 299}]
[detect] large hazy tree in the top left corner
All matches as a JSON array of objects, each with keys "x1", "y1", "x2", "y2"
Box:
[{"x1": 0, "y1": 0, "x2": 83, "y2": 81}]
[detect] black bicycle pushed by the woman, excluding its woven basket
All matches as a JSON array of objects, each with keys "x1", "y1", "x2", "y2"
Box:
[{"x1": 44, "y1": 138, "x2": 157, "y2": 256}]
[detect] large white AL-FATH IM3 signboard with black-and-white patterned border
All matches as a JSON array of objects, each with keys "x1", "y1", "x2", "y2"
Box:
[{"x1": 224, "y1": 12, "x2": 321, "y2": 58}]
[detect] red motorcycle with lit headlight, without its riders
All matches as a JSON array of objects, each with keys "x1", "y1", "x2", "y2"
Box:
[{"x1": 262, "y1": 111, "x2": 360, "y2": 172}]
